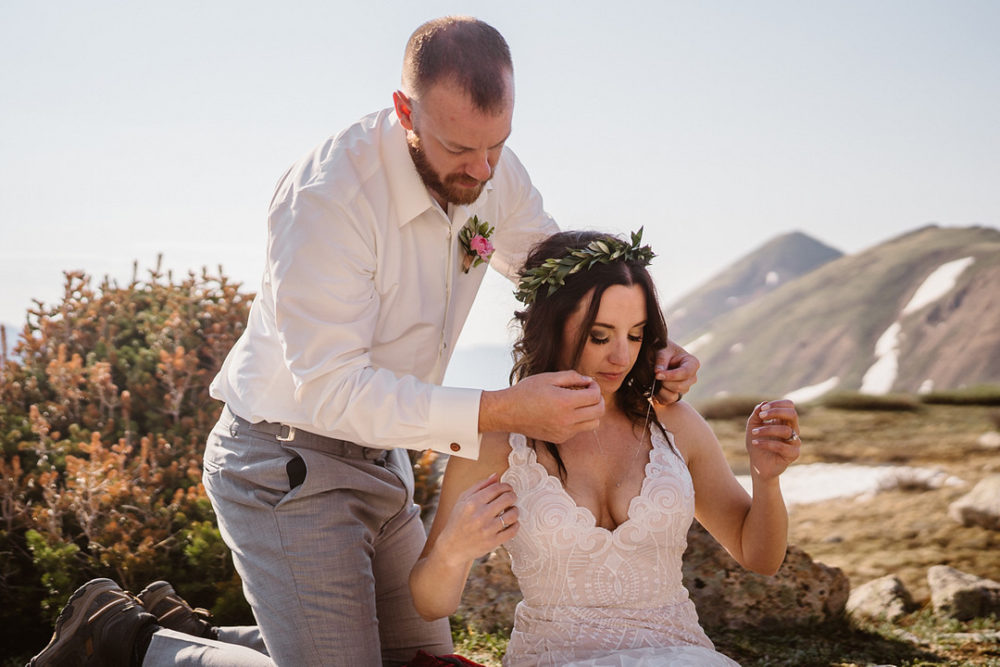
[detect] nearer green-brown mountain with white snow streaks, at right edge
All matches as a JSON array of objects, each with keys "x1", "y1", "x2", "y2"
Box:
[{"x1": 667, "y1": 225, "x2": 1000, "y2": 400}]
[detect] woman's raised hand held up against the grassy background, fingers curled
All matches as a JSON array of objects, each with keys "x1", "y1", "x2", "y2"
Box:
[{"x1": 746, "y1": 399, "x2": 802, "y2": 480}]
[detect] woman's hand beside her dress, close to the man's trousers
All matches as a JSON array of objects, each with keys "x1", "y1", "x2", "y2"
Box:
[{"x1": 434, "y1": 473, "x2": 519, "y2": 562}]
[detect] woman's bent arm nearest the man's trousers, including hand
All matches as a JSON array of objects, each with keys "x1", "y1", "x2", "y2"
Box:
[{"x1": 410, "y1": 433, "x2": 518, "y2": 620}]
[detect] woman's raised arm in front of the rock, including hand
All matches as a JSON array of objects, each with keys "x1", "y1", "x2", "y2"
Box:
[{"x1": 661, "y1": 401, "x2": 800, "y2": 575}]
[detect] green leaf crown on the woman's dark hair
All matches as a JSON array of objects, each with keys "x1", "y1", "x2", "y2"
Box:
[{"x1": 514, "y1": 227, "x2": 656, "y2": 305}]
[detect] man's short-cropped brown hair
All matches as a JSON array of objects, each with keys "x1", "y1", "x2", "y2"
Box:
[{"x1": 403, "y1": 16, "x2": 514, "y2": 112}]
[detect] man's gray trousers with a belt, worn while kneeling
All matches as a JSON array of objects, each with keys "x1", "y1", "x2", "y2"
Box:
[{"x1": 155, "y1": 407, "x2": 452, "y2": 666}]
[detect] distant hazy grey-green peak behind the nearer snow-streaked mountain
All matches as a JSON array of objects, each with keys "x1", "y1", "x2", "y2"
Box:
[{"x1": 665, "y1": 232, "x2": 843, "y2": 340}]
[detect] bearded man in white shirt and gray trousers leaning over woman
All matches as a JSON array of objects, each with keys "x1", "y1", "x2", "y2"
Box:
[{"x1": 27, "y1": 17, "x2": 698, "y2": 665}]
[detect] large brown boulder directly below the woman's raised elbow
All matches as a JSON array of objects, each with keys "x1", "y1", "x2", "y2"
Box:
[{"x1": 683, "y1": 522, "x2": 850, "y2": 629}]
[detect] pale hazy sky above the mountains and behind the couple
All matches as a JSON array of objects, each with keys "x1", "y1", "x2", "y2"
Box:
[{"x1": 0, "y1": 0, "x2": 1000, "y2": 346}]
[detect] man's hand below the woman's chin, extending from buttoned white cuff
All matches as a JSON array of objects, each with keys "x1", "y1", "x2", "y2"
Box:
[{"x1": 479, "y1": 371, "x2": 604, "y2": 443}]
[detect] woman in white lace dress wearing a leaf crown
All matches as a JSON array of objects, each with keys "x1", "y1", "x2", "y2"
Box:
[{"x1": 410, "y1": 230, "x2": 800, "y2": 667}]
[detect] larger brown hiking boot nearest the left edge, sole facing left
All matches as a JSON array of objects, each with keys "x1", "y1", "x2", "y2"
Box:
[{"x1": 28, "y1": 579, "x2": 156, "y2": 667}]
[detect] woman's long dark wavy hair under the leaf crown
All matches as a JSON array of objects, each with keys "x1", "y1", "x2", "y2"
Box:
[{"x1": 510, "y1": 231, "x2": 667, "y2": 481}]
